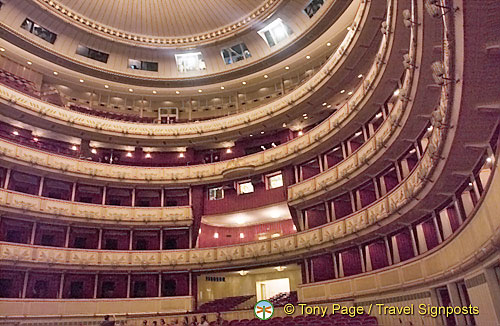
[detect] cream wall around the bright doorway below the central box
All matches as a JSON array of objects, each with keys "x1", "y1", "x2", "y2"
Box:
[{"x1": 198, "y1": 268, "x2": 302, "y2": 304}]
